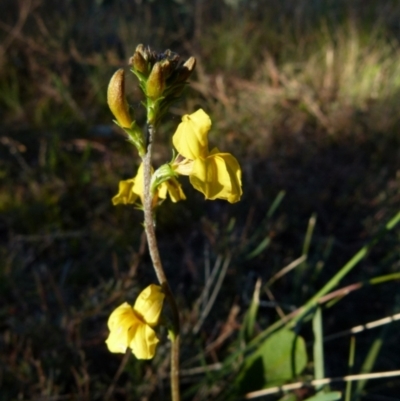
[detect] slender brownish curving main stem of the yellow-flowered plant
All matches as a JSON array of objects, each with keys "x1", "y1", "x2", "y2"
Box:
[{"x1": 143, "y1": 124, "x2": 180, "y2": 401}]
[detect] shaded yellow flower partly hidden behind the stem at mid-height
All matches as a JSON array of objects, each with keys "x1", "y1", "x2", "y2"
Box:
[{"x1": 112, "y1": 163, "x2": 186, "y2": 206}]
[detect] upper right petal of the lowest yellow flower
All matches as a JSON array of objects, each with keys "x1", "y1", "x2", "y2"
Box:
[{"x1": 133, "y1": 284, "x2": 165, "y2": 326}]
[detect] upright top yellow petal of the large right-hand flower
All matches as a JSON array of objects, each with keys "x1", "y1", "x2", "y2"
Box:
[{"x1": 172, "y1": 109, "x2": 211, "y2": 160}]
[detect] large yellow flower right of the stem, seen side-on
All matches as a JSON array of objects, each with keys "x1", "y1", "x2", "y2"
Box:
[{"x1": 172, "y1": 109, "x2": 242, "y2": 203}]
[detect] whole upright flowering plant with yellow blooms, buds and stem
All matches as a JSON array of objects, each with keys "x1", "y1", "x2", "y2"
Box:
[{"x1": 106, "y1": 45, "x2": 242, "y2": 401}]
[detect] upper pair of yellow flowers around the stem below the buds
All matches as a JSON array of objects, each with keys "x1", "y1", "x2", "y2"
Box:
[{"x1": 112, "y1": 109, "x2": 242, "y2": 206}]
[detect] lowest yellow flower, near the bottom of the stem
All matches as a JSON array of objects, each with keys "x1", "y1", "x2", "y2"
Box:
[{"x1": 106, "y1": 284, "x2": 165, "y2": 359}]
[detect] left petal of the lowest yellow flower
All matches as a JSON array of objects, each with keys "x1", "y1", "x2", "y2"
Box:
[{"x1": 106, "y1": 302, "x2": 142, "y2": 353}]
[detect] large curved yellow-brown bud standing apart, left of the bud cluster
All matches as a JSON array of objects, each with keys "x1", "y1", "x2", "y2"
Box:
[{"x1": 107, "y1": 68, "x2": 133, "y2": 128}]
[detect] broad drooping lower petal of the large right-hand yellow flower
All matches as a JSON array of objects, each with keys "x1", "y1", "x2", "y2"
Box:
[{"x1": 190, "y1": 149, "x2": 242, "y2": 203}]
